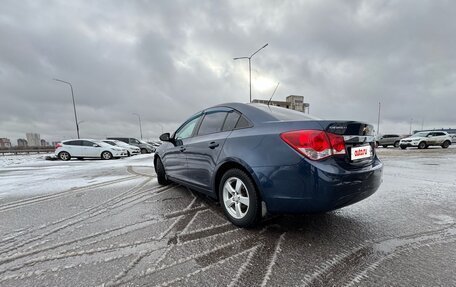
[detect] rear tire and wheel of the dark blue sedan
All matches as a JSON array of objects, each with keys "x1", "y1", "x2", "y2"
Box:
[{"x1": 219, "y1": 169, "x2": 261, "y2": 228}]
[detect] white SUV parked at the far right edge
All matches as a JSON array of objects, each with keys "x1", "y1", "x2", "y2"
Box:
[{"x1": 399, "y1": 131, "x2": 451, "y2": 149}]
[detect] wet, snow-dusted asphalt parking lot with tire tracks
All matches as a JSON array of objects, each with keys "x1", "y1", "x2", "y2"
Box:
[{"x1": 0, "y1": 147, "x2": 456, "y2": 286}]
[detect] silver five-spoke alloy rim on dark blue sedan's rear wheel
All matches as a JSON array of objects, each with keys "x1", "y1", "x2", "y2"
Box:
[{"x1": 223, "y1": 177, "x2": 250, "y2": 219}]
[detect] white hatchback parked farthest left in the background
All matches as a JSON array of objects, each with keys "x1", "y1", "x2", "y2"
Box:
[{"x1": 55, "y1": 139, "x2": 127, "y2": 160}]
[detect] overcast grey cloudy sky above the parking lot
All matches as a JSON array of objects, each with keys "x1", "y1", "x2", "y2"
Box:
[{"x1": 0, "y1": 0, "x2": 456, "y2": 143}]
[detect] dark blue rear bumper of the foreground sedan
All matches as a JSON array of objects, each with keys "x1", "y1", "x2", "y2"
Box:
[{"x1": 253, "y1": 158, "x2": 383, "y2": 213}]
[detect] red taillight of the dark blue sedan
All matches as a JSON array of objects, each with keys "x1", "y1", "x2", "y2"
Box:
[{"x1": 280, "y1": 130, "x2": 345, "y2": 160}]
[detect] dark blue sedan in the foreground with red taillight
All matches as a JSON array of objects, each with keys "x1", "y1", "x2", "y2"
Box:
[{"x1": 154, "y1": 103, "x2": 383, "y2": 227}]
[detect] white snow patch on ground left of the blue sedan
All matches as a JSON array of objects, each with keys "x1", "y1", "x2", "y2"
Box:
[{"x1": 0, "y1": 154, "x2": 153, "y2": 199}]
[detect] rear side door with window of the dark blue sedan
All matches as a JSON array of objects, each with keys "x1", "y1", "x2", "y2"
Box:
[{"x1": 184, "y1": 107, "x2": 240, "y2": 190}]
